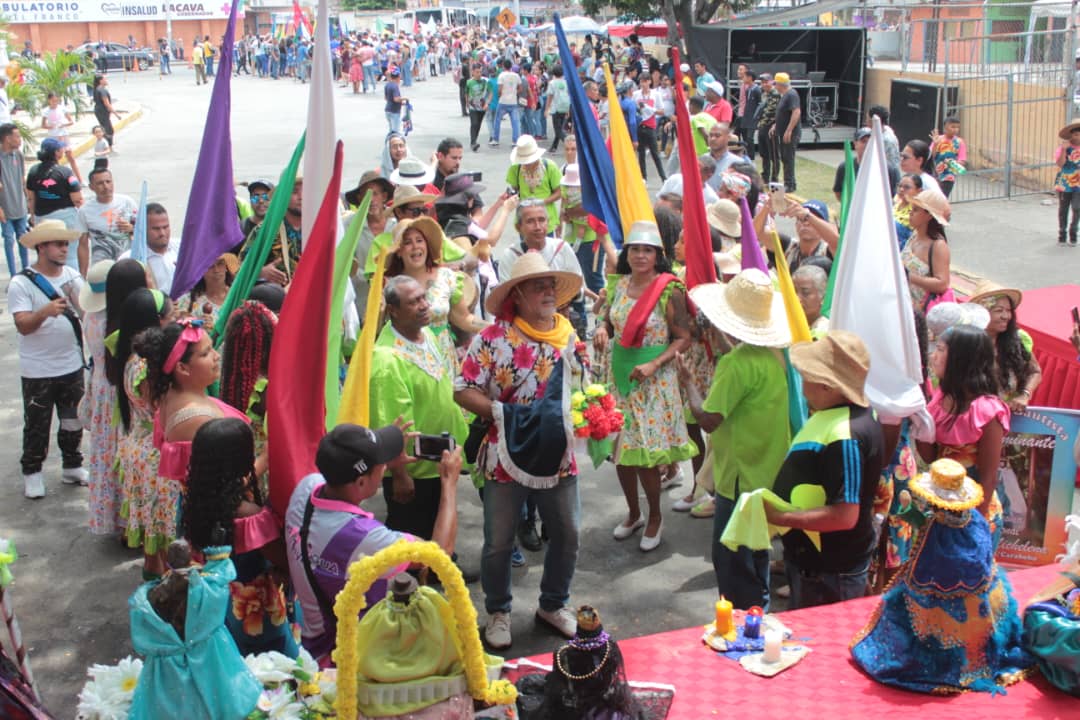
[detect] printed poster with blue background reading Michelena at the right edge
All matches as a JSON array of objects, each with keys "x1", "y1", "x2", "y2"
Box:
[{"x1": 997, "y1": 408, "x2": 1080, "y2": 566}]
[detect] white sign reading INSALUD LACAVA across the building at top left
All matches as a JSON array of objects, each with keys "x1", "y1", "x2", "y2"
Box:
[{"x1": 0, "y1": 0, "x2": 236, "y2": 24}]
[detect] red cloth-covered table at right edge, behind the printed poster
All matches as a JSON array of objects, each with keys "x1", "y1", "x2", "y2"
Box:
[{"x1": 1016, "y1": 285, "x2": 1080, "y2": 409}]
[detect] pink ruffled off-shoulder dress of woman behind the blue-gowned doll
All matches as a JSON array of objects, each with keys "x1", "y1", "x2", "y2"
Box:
[{"x1": 927, "y1": 390, "x2": 1011, "y2": 551}]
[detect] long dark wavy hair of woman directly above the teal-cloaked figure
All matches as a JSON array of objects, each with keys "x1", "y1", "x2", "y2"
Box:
[{"x1": 181, "y1": 418, "x2": 262, "y2": 548}]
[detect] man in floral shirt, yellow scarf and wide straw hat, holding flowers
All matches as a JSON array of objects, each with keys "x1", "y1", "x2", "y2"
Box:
[{"x1": 454, "y1": 253, "x2": 589, "y2": 650}]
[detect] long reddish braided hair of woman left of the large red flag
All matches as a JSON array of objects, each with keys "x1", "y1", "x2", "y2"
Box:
[{"x1": 221, "y1": 300, "x2": 278, "y2": 410}]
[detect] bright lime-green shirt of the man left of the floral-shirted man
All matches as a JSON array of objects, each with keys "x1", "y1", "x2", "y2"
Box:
[{"x1": 368, "y1": 323, "x2": 469, "y2": 478}]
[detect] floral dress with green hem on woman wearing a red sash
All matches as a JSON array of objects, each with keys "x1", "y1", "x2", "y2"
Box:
[{"x1": 608, "y1": 275, "x2": 698, "y2": 467}]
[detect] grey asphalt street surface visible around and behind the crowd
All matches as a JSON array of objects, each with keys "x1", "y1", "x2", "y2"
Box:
[{"x1": 0, "y1": 68, "x2": 1080, "y2": 718}]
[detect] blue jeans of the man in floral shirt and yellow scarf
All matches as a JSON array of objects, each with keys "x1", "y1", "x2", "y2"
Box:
[{"x1": 480, "y1": 476, "x2": 581, "y2": 614}]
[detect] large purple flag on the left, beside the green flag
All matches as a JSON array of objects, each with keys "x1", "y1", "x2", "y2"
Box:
[{"x1": 171, "y1": 0, "x2": 244, "y2": 300}]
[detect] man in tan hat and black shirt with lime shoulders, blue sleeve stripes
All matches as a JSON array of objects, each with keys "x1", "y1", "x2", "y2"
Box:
[{"x1": 765, "y1": 330, "x2": 885, "y2": 608}]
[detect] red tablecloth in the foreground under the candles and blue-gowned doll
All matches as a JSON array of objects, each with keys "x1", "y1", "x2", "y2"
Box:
[{"x1": 509, "y1": 566, "x2": 1080, "y2": 720}]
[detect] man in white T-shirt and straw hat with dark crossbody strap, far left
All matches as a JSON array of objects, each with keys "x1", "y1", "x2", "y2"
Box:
[{"x1": 8, "y1": 220, "x2": 87, "y2": 498}]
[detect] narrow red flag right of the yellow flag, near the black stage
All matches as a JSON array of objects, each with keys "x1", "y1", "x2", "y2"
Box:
[{"x1": 672, "y1": 47, "x2": 716, "y2": 288}]
